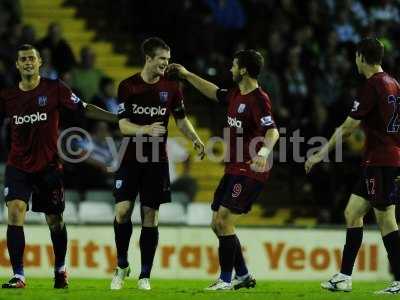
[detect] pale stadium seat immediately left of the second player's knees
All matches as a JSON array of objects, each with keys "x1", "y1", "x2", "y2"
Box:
[{"x1": 78, "y1": 201, "x2": 114, "y2": 224}]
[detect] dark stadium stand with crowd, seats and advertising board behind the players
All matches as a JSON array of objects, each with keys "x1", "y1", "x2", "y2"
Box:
[{"x1": 0, "y1": 0, "x2": 400, "y2": 279}]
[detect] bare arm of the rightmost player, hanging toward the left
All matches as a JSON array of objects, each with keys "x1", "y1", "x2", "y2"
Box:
[{"x1": 305, "y1": 117, "x2": 361, "y2": 174}]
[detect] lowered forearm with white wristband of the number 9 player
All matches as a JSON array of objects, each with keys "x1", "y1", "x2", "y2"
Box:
[{"x1": 250, "y1": 128, "x2": 279, "y2": 172}]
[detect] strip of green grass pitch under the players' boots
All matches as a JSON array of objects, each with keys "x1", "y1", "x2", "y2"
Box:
[{"x1": 0, "y1": 278, "x2": 390, "y2": 300}]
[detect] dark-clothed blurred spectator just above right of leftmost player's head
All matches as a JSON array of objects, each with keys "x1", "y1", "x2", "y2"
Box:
[{"x1": 38, "y1": 23, "x2": 76, "y2": 74}]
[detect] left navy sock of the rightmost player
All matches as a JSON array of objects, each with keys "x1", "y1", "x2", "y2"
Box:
[{"x1": 340, "y1": 227, "x2": 363, "y2": 276}]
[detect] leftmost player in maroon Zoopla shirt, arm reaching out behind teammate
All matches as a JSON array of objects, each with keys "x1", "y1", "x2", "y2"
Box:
[{"x1": 0, "y1": 45, "x2": 117, "y2": 288}]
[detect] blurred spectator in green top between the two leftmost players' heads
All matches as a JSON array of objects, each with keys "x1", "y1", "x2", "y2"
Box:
[{"x1": 71, "y1": 47, "x2": 104, "y2": 102}]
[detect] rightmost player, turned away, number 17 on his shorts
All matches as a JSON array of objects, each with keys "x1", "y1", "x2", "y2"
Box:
[{"x1": 305, "y1": 38, "x2": 400, "y2": 294}]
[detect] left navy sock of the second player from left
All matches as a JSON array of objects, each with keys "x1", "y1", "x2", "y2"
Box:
[{"x1": 114, "y1": 220, "x2": 132, "y2": 269}]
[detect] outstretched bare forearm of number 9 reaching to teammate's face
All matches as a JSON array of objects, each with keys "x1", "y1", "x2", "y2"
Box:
[{"x1": 168, "y1": 64, "x2": 219, "y2": 101}]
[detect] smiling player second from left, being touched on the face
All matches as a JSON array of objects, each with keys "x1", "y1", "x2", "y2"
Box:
[{"x1": 110, "y1": 37, "x2": 204, "y2": 290}]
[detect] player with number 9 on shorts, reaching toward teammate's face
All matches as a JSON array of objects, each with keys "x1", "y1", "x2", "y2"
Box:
[{"x1": 170, "y1": 50, "x2": 279, "y2": 290}]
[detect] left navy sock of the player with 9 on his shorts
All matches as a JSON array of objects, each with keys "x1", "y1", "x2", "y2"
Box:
[{"x1": 218, "y1": 235, "x2": 236, "y2": 282}]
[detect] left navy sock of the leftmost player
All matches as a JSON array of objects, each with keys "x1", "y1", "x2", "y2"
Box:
[{"x1": 7, "y1": 225, "x2": 25, "y2": 276}]
